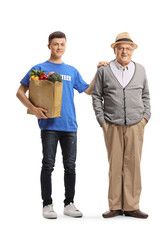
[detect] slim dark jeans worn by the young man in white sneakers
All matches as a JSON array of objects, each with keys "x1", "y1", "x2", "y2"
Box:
[{"x1": 41, "y1": 130, "x2": 77, "y2": 207}]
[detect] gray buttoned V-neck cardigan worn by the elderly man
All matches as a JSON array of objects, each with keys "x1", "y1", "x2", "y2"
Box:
[{"x1": 92, "y1": 63, "x2": 151, "y2": 126}]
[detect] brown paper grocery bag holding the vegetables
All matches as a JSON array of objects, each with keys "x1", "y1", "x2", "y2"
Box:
[{"x1": 27, "y1": 79, "x2": 63, "y2": 118}]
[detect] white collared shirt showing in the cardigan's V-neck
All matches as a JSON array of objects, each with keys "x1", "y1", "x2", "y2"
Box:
[{"x1": 110, "y1": 60, "x2": 135, "y2": 87}]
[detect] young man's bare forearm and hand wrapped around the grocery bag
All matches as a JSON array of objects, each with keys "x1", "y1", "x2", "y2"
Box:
[{"x1": 16, "y1": 84, "x2": 47, "y2": 119}]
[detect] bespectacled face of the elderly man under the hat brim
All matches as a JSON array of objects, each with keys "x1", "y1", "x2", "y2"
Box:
[{"x1": 114, "y1": 43, "x2": 134, "y2": 66}]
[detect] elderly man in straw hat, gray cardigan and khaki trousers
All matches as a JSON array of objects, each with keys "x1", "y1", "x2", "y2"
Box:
[{"x1": 92, "y1": 32, "x2": 151, "y2": 218}]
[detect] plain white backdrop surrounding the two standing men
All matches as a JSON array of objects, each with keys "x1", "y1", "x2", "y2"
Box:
[{"x1": 0, "y1": 0, "x2": 160, "y2": 240}]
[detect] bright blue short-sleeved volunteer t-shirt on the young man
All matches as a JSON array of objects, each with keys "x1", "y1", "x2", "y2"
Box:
[{"x1": 20, "y1": 61, "x2": 89, "y2": 132}]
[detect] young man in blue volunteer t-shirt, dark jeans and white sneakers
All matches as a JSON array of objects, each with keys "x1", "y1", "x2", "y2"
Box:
[{"x1": 17, "y1": 32, "x2": 93, "y2": 218}]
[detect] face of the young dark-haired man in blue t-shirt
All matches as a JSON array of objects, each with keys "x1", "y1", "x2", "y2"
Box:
[{"x1": 48, "y1": 38, "x2": 66, "y2": 59}]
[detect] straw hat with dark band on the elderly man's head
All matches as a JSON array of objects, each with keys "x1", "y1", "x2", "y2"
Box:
[{"x1": 111, "y1": 32, "x2": 138, "y2": 49}]
